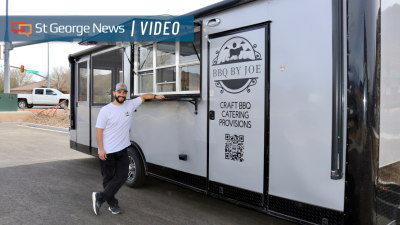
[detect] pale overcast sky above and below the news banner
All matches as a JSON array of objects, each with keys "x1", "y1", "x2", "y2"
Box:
[{"x1": 0, "y1": 0, "x2": 220, "y2": 80}]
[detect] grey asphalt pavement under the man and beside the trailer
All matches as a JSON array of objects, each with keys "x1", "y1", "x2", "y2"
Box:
[{"x1": 0, "y1": 123, "x2": 293, "y2": 225}]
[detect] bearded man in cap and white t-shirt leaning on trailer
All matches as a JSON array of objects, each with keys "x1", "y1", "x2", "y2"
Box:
[{"x1": 92, "y1": 83, "x2": 164, "y2": 215}]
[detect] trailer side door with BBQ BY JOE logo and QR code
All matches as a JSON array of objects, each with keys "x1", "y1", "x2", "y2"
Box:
[{"x1": 208, "y1": 25, "x2": 269, "y2": 205}]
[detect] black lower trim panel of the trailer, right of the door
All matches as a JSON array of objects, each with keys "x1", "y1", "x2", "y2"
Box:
[{"x1": 268, "y1": 195, "x2": 343, "y2": 225}]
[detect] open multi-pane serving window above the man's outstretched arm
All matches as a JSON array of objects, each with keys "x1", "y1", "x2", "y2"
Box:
[{"x1": 135, "y1": 32, "x2": 201, "y2": 94}]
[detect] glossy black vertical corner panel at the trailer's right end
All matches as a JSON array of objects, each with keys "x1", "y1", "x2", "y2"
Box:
[{"x1": 344, "y1": 0, "x2": 380, "y2": 224}]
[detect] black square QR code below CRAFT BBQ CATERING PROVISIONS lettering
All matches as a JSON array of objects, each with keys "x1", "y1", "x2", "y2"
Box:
[{"x1": 225, "y1": 134, "x2": 244, "y2": 162}]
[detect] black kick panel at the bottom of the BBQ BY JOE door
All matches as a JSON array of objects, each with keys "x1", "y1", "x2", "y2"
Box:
[{"x1": 208, "y1": 181, "x2": 263, "y2": 206}]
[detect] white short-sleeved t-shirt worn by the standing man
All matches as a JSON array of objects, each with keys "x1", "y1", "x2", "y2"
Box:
[{"x1": 96, "y1": 97, "x2": 142, "y2": 154}]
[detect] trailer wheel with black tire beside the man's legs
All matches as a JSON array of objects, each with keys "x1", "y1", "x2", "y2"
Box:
[{"x1": 126, "y1": 148, "x2": 146, "y2": 188}]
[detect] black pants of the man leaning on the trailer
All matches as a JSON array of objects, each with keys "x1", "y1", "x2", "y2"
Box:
[{"x1": 98, "y1": 148, "x2": 129, "y2": 205}]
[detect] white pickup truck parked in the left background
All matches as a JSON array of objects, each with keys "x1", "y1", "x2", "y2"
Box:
[{"x1": 18, "y1": 88, "x2": 69, "y2": 109}]
